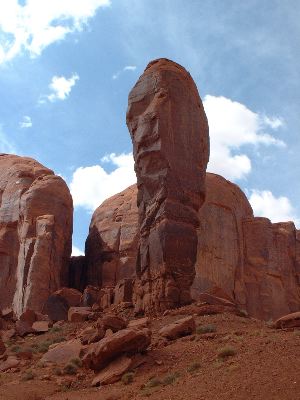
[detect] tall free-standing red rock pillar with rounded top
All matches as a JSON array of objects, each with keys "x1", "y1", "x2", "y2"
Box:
[{"x1": 126, "y1": 59, "x2": 209, "y2": 312}]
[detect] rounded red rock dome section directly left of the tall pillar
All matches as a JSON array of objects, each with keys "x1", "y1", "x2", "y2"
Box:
[{"x1": 85, "y1": 185, "x2": 138, "y2": 287}]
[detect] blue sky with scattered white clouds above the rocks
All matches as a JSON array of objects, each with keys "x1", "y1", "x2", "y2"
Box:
[{"x1": 0, "y1": 0, "x2": 300, "y2": 255}]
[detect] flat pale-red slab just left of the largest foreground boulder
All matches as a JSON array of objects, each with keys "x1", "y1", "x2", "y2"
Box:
[{"x1": 41, "y1": 339, "x2": 82, "y2": 364}]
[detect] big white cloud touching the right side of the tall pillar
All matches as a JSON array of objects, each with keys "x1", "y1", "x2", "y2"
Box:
[{"x1": 203, "y1": 95, "x2": 285, "y2": 180}]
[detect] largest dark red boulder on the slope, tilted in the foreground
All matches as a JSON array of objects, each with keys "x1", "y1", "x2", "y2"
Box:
[{"x1": 83, "y1": 328, "x2": 151, "y2": 371}]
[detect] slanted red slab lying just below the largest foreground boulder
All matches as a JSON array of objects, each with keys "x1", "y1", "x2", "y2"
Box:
[{"x1": 92, "y1": 356, "x2": 132, "y2": 386}]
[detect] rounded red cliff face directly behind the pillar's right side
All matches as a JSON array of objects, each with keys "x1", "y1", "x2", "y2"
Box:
[{"x1": 192, "y1": 173, "x2": 253, "y2": 300}]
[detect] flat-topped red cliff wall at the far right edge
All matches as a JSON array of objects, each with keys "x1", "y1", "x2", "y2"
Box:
[{"x1": 241, "y1": 218, "x2": 300, "y2": 320}]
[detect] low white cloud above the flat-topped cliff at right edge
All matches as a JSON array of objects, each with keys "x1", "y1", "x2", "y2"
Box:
[{"x1": 249, "y1": 190, "x2": 300, "y2": 224}]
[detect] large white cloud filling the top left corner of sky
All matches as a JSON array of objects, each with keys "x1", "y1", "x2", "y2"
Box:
[{"x1": 0, "y1": 0, "x2": 111, "y2": 64}]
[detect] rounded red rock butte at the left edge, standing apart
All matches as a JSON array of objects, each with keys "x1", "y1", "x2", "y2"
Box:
[{"x1": 0, "y1": 154, "x2": 73, "y2": 315}]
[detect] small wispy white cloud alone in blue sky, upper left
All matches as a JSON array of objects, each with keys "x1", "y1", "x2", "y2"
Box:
[{"x1": 39, "y1": 74, "x2": 79, "y2": 104}]
